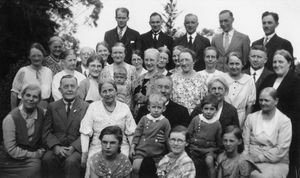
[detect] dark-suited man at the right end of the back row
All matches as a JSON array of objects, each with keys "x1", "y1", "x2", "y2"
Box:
[{"x1": 252, "y1": 11, "x2": 293, "y2": 71}]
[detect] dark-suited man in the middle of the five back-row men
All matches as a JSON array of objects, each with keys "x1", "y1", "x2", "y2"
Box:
[{"x1": 174, "y1": 14, "x2": 210, "y2": 71}]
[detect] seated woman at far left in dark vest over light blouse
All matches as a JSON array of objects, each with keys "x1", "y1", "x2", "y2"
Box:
[{"x1": 0, "y1": 84, "x2": 45, "y2": 178}]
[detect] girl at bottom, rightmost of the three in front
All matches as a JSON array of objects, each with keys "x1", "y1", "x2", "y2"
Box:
[{"x1": 217, "y1": 125, "x2": 260, "y2": 178}]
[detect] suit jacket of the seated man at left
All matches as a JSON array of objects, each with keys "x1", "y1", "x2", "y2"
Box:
[{"x1": 43, "y1": 97, "x2": 88, "y2": 152}]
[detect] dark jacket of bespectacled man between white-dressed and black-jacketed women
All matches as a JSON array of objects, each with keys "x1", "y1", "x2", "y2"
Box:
[{"x1": 244, "y1": 67, "x2": 273, "y2": 112}]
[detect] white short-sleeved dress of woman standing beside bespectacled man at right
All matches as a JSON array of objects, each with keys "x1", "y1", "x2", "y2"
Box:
[{"x1": 223, "y1": 73, "x2": 256, "y2": 128}]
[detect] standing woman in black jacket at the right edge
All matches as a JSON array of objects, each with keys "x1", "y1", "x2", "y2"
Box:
[{"x1": 259, "y1": 50, "x2": 300, "y2": 176}]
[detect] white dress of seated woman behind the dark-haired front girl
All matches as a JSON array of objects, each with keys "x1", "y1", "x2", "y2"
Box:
[{"x1": 79, "y1": 100, "x2": 136, "y2": 177}]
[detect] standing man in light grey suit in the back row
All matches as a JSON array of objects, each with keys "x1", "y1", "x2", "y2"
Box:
[{"x1": 211, "y1": 10, "x2": 250, "y2": 72}]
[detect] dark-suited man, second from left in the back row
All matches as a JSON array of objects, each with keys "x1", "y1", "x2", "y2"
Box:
[{"x1": 141, "y1": 12, "x2": 175, "y2": 70}]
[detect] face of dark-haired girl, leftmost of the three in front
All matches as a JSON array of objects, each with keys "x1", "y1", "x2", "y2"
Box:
[{"x1": 101, "y1": 134, "x2": 121, "y2": 158}]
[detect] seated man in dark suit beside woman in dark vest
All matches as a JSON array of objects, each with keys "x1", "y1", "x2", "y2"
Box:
[{"x1": 42, "y1": 75, "x2": 88, "y2": 178}]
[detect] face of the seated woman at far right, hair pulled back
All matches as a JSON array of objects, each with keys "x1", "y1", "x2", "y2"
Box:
[{"x1": 259, "y1": 91, "x2": 278, "y2": 112}]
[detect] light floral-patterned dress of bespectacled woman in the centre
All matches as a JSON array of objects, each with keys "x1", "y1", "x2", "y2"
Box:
[{"x1": 171, "y1": 73, "x2": 207, "y2": 114}]
